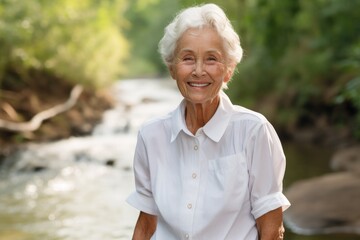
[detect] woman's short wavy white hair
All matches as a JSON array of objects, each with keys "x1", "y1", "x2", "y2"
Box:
[{"x1": 159, "y1": 4, "x2": 243, "y2": 67}]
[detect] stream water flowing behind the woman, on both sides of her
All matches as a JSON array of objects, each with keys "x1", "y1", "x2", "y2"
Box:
[{"x1": 0, "y1": 80, "x2": 360, "y2": 240}]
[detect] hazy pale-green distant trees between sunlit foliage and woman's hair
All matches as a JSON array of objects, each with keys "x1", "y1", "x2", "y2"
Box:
[{"x1": 125, "y1": 0, "x2": 179, "y2": 77}]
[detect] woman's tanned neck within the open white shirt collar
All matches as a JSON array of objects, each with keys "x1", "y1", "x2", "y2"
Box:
[{"x1": 185, "y1": 96, "x2": 220, "y2": 135}]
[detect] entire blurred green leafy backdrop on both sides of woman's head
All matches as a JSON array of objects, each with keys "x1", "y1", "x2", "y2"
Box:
[{"x1": 0, "y1": 0, "x2": 360, "y2": 139}]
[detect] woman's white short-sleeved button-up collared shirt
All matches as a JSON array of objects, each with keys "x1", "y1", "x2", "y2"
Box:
[{"x1": 127, "y1": 93, "x2": 290, "y2": 240}]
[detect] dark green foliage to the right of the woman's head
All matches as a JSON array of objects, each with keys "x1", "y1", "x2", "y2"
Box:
[{"x1": 225, "y1": 0, "x2": 360, "y2": 139}]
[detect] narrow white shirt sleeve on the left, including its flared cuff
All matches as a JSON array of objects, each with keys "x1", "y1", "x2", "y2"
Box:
[{"x1": 126, "y1": 131, "x2": 158, "y2": 215}]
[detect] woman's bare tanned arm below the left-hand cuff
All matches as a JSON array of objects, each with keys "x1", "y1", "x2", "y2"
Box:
[{"x1": 132, "y1": 212, "x2": 157, "y2": 240}]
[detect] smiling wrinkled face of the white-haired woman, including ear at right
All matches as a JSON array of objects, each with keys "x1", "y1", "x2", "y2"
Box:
[{"x1": 169, "y1": 27, "x2": 232, "y2": 104}]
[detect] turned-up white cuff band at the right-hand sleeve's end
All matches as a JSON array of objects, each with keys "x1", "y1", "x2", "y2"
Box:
[{"x1": 251, "y1": 192, "x2": 291, "y2": 219}]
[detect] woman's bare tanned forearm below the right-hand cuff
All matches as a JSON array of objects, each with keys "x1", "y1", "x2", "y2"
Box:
[{"x1": 256, "y1": 207, "x2": 285, "y2": 240}]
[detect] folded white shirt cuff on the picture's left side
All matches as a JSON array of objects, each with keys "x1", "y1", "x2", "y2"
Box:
[{"x1": 126, "y1": 192, "x2": 158, "y2": 215}]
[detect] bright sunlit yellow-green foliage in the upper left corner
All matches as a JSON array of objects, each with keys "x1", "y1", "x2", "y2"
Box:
[{"x1": 0, "y1": 0, "x2": 128, "y2": 86}]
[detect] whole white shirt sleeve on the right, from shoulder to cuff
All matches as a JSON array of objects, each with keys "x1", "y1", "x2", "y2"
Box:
[{"x1": 247, "y1": 121, "x2": 290, "y2": 219}]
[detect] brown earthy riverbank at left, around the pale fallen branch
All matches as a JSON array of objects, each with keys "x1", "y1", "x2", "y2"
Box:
[{"x1": 0, "y1": 79, "x2": 114, "y2": 161}]
